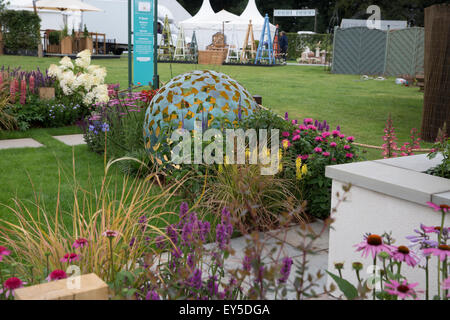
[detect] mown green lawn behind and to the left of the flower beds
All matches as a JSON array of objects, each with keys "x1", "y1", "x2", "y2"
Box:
[{"x1": 0, "y1": 56, "x2": 423, "y2": 218}]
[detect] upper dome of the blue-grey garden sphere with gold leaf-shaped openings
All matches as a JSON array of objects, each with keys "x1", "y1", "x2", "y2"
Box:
[{"x1": 144, "y1": 70, "x2": 257, "y2": 153}]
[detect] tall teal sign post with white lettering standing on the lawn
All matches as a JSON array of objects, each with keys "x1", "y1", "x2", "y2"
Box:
[{"x1": 132, "y1": 0, "x2": 159, "y2": 88}]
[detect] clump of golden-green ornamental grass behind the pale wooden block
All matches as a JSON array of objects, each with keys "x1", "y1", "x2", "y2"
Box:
[{"x1": 0, "y1": 159, "x2": 183, "y2": 284}]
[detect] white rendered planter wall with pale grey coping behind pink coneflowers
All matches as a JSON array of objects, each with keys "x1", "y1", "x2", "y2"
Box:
[{"x1": 326, "y1": 155, "x2": 450, "y2": 297}]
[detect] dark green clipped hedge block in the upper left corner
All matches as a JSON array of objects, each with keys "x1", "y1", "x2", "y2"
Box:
[{"x1": 0, "y1": 10, "x2": 41, "y2": 50}]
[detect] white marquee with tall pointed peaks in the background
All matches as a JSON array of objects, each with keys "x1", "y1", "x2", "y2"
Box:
[{"x1": 180, "y1": 0, "x2": 275, "y2": 50}]
